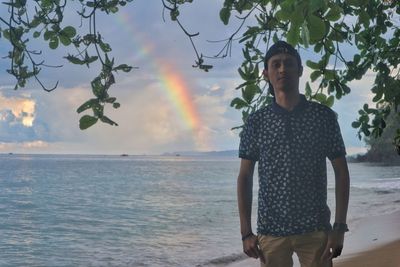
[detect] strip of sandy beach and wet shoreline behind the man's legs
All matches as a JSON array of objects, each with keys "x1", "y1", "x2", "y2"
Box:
[{"x1": 222, "y1": 211, "x2": 400, "y2": 267}]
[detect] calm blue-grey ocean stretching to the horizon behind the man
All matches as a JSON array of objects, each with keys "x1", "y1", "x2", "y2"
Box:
[{"x1": 0, "y1": 154, "x2": 400, "y2": 267}]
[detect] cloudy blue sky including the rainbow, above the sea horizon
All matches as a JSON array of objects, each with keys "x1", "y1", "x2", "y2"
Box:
[{"x1": 0, "y1": 0, "x2": 374, "y2": 154}]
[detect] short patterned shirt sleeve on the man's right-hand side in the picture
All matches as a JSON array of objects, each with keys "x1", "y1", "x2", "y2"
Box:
[{"x1": 326, "y1": 111, "x2": 346, "y2": 160}]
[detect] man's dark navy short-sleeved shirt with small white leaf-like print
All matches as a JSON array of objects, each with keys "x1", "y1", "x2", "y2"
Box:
[{"x1": 239, "y1": 95, "x2": 346, "y2": 236}]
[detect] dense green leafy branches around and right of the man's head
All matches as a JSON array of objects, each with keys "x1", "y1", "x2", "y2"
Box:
[{"x1": 167, "y1": 0, "x2": 400, "y2": 154}]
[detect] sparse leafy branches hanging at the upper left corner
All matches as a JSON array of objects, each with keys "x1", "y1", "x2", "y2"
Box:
[{"x1": 0, "y1": 0, "x2": 132, "y2": 129}]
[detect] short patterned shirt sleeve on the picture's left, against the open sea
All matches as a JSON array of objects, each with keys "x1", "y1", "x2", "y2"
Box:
[{"x1": 239, "y1": 115, "x2": 259, "y2": 161}]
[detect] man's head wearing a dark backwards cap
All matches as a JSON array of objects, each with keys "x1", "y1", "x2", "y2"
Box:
[{"x1": 264, "y1": 41, "x2": 303, "y2": 95}]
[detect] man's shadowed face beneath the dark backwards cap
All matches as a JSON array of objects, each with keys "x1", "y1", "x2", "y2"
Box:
[{"x1": 264, "y1": 54, "x2": 303, "y2": 93}]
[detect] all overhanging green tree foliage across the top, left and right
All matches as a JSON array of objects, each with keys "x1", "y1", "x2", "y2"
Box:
[{"x1": 0, "y1": 0, "x2": 400, "y2": 155}]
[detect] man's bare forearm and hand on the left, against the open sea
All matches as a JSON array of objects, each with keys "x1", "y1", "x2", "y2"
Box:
[{"x1": 237, "y1": 159, "x2": 263, "y2": 261}]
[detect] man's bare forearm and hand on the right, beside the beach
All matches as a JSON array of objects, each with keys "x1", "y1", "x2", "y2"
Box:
[{"x1": 322, "y1": 156, "x2": 350, "y2": 259}]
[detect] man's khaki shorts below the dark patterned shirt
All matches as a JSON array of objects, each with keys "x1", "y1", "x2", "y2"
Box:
[{"x1": 258, "y1": 231, "x2": 332, "y2": 267}]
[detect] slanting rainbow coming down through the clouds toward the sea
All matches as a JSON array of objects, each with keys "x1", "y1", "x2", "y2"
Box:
[{"x1": 112, "y1": 10, "x2": 209, "y2": 150}]
